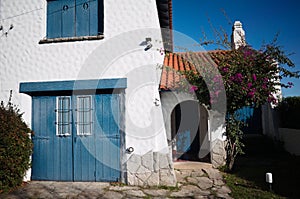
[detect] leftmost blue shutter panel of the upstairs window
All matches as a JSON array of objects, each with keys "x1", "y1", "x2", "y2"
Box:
[{"x1": 47, "y1": 1, "x2": 62, "y2": 38}]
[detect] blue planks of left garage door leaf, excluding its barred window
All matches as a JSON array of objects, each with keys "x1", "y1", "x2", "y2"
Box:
[{"x1": 31, "y1": 96, "x2": 73, "y2": 181}]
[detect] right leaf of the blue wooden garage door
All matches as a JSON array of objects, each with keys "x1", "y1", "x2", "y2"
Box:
[{"x1": 74, "y1": 94, "x2": 120, "y2": 181}]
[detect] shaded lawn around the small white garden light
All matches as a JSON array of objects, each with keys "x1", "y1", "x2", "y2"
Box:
[{"x1": 224, "y1": 136, "x2": 300, "y2": 198}]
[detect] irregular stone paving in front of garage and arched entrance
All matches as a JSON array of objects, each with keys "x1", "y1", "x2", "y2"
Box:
[{"x1": 0, "y1": 162, "x2": 231, "y2": 199}]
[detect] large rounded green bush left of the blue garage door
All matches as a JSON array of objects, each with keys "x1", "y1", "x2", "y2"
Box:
[{"x1": 0, "y1": 93, "x2": 32, "y2": 193}]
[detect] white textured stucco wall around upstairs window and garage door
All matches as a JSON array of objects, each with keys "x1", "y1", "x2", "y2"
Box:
[{"x1": 0, "y1": 0, "x2": 167, "y2": 180}]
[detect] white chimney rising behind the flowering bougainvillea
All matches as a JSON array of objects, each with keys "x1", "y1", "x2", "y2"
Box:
[{"x1": 231, "y1": 21, "x2": 246, "y2": 50}]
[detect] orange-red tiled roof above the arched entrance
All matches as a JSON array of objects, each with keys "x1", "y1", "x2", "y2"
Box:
[{"x1": 159, "y1": 50, "x2": 230, "y2": 90}]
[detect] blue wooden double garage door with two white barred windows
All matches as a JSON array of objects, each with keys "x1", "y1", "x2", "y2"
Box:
[{"x1": 32, "y1": 94, "x2": 120, "y2": 181}]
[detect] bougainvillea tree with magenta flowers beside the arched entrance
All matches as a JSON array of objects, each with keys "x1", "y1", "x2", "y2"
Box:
[{"x1": 180, "y1": 37, "x2": 299, "y2": 170}]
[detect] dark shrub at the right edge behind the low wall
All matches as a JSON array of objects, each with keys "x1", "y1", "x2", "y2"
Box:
[{"x1": 277, "y1": 96, "x2": 300, "y2": 129}]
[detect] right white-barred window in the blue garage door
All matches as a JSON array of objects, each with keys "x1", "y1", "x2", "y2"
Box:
[{"x1": 75, "y1": 95, "x2": 94, "y2": 136}]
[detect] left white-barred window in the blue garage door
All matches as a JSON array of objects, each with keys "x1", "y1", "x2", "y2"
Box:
[{"x1": 55, "y1": 96, "x2": 73, "y2": 136}]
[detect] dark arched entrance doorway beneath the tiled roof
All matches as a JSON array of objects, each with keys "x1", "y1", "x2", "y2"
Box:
[{"x1": 171, "y1": 100, "x2": 210, "y2": 162}]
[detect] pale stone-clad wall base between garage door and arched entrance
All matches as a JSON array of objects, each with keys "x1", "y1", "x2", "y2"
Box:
[{"x1": 127, "y1": 151, "x2": 176, "y2": 187}]
